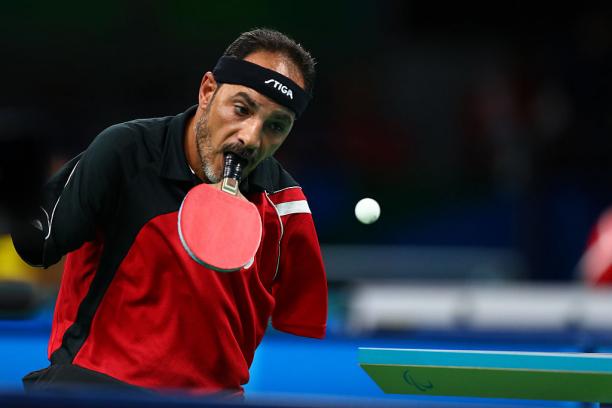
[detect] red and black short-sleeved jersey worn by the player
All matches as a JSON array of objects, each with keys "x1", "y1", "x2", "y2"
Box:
[{"x1": 20, "y1": 107, "x2": 327, "y2": 393}]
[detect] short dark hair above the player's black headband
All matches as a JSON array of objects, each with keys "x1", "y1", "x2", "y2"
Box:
[{"x1": 223, "y1": 28, "x2": 315, "y2": 93}]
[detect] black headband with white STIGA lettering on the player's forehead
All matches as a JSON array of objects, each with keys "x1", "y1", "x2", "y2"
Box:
[{"x1": 213, "y1": 57, "x2": 312, "y2": 118}]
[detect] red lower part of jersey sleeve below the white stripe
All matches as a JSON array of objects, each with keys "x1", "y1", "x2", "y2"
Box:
[{"x1": 272, "y1": 207, "x2": 327, "y2": 338}]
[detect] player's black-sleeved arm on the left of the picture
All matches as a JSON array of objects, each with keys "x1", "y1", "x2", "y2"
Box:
[{"x1": 13, "y1": 126, "x2": 130, "y2": 267}]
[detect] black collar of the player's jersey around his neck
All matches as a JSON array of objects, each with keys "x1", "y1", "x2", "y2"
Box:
[{"x1": 160, "y1": 105, "x2": 277, "y2": 193}]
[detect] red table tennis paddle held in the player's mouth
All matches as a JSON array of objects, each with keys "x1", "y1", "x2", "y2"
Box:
[{"x1": 178, "y1": 153, "x2": 262, "y2": 272}]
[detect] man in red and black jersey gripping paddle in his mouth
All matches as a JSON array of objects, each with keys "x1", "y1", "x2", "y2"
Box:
[{"x1": 13, "y1": 29, "x2": 327, "y2": 393}]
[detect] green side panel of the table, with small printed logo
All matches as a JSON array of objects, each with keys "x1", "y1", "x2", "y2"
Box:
[{"x1": 360, "y1": 364, "x2": 612, "y2": 402}]
